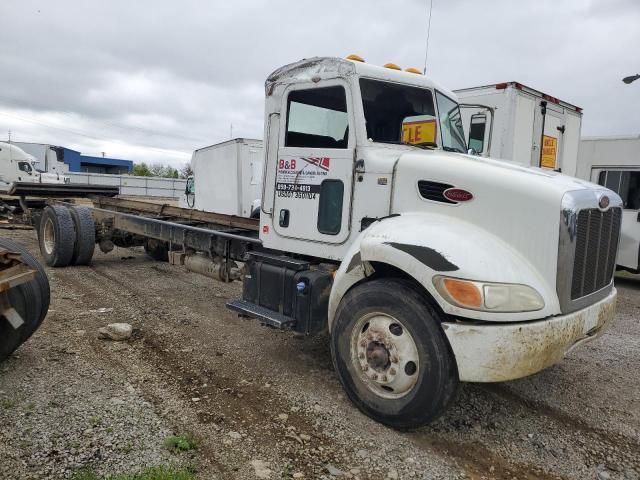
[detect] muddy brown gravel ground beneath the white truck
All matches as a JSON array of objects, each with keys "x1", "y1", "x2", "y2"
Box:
[{"x1": 0, "y1": 231, "x2": 640, "y2": 480}]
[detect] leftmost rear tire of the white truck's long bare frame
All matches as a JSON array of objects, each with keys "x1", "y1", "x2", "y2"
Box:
[{"x1": 38, "y1": 205, "x2": 76, "y2": 267}]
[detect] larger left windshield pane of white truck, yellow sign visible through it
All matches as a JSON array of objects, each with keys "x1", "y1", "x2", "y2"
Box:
[{"x1": 360, "y1": 78, "x2": 437, "y2": 146}]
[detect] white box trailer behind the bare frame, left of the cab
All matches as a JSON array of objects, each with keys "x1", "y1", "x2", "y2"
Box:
[{"x1": 180, "y1": 138, "x2": 263, "y2": 218}]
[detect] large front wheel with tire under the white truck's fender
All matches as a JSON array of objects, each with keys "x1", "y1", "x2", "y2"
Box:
[{"x1": 331, "y1": 278, "x2": 459, "y2": 430}]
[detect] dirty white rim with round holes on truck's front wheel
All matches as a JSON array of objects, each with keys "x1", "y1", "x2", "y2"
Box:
[{"x1": 351, "y1": 312, "x2": 420, "y2": 399}]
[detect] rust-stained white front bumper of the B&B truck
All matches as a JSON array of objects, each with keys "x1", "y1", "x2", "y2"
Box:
[{"x1": 442, "y1": 288, "x2": 617, "y2": 382}]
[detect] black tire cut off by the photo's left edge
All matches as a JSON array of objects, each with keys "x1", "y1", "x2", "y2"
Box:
[{"x1": 0, "y1": 238, "x2": 50, "y2": 361}]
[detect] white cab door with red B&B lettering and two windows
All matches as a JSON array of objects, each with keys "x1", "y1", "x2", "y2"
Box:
[{"x1": 273, "y1": 80, "x2": 355, "y2": 243}]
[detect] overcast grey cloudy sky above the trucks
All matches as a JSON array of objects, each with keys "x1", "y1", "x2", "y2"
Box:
[{"x1": 0, "y1": 0, "x2": 640, "y2": 166}]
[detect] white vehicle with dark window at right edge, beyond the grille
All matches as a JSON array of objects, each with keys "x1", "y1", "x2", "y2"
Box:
[{"x1": 577, "y1": 135, "x2": 640, "y2": 273}]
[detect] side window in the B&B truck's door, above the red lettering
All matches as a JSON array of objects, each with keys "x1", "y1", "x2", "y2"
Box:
[{"x1": 284, "y1": 87, "x2": 349, "y2": 148}]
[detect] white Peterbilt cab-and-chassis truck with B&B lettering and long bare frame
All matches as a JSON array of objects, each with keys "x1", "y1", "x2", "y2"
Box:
[{"x1": 40, "y1": 57, "x2": 621, "y2": 428}]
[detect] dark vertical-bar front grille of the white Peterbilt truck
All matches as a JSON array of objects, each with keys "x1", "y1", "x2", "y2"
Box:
[{"x1": 571, "y1": 208, "x2": 622, "y2": 300}]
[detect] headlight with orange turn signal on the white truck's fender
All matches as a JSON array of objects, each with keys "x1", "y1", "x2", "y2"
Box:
[{"x1": 433, "y1": 276, "x2": 544, "y2": 312}]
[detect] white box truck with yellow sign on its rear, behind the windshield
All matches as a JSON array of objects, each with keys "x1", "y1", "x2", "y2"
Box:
[{"x1": 455, "y1": 82, "x2": 582, "y2": 175}]
